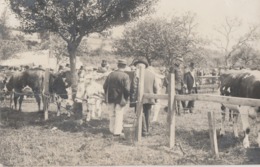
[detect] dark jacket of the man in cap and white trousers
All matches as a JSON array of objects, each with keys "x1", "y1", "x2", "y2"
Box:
[{"x1": 103, "y1": 70, "x2": 130, "y2": 106}]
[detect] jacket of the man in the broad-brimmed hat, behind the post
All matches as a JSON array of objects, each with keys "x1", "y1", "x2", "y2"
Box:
[{"x1": 130, "y1": 69, "x2": 159, "y2": 107}]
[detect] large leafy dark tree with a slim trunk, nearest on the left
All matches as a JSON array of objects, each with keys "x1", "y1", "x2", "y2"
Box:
[{"x1": 9, "y1": 0, "x2": 154, "y2": 98}]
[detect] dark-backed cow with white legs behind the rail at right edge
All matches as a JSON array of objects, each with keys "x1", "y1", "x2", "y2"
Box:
[{"x1": 220, "y1": 70, "x2": 260, "y2": 148}]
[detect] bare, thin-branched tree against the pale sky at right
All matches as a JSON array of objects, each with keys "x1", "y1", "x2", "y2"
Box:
[{"x1": 215, "y1": 18, "x2": 259, "y2": 66}]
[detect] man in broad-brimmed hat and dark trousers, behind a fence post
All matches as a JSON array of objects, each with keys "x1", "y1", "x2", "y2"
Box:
[{"x1": 130, "y1": 58, "x2": 159, "y2": 136}]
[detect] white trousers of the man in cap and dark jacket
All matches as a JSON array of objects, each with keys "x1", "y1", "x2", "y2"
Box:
[{"x1": 107, "y1": 103, "x2": 126, "y2": 135}]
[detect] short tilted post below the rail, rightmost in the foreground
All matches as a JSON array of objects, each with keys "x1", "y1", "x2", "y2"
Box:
[{"x1": 208, "y1": 111, "x2": 219, "y2": 158}]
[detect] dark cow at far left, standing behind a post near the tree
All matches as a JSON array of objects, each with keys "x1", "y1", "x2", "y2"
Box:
[{"x1": 5, "y1": 68, "x2": 71, "y2": 111}]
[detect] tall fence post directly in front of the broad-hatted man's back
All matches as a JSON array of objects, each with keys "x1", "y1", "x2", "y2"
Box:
[{"x1": 136, "y1": 66, "x2": 144, "y2": 144}]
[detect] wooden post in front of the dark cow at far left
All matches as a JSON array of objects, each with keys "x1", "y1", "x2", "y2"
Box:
[{"x1": 43, "y1": 68, "x2": 50, "y2": 120}]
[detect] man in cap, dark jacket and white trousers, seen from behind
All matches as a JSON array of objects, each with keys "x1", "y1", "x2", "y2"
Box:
[{"x1": 103, "y1": 60, "x2": 130, "y2": 136}]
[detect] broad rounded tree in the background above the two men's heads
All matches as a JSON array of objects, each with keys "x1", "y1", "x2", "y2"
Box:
[{"x1": 114, "y1": 13, "x2": 199, "y2": 66}]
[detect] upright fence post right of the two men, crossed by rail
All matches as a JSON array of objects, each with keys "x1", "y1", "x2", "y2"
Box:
[{"x1": 167, "y1": 74, "x2": 176, "y2": 148}]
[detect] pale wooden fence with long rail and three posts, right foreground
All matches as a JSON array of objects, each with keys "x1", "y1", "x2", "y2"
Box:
[{"x1": 136, "y1": 67, "x2": 260, "y2": 157}]
